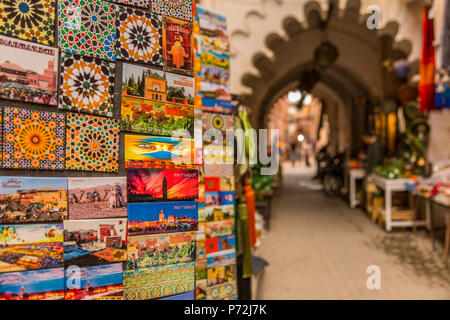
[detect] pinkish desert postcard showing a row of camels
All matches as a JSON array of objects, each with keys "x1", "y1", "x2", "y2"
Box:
[{"x1": 69, "y1": 177, "x2": 127, "y2": 220}]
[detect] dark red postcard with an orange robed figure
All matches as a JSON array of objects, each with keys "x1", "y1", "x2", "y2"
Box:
[{"x1": 163, "y1": 17, "x2": 194, "y2": 76}]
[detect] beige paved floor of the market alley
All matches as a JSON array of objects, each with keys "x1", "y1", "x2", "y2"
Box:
[{"x1": 255, "y1": 164, "x2": 450, "y2": 299}]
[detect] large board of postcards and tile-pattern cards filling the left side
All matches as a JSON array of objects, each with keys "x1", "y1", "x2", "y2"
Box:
[{"x1": 0, "y1": 0, "x2": 201, "y2": 300}]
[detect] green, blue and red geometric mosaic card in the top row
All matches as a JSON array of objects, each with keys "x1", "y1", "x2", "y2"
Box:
[{"x1": 58, "y1": 0, "x2": 116, "y2": 61}]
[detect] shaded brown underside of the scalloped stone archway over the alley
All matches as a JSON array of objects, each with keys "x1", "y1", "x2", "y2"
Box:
[{"x1": 241, "y1": 0, "x2": 411, "y2": 151}]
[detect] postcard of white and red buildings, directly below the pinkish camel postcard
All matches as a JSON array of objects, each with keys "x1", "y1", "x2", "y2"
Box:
[{"x1": 64, "y1": 218, "x2": 127, "y2": 266}]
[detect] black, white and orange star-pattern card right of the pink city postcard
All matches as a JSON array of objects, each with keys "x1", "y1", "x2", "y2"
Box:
[{"x1": 59, "y1": 53, "x2": 115, "y2": 117}]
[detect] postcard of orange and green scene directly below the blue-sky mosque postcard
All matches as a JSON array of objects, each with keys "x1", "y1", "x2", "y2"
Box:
[{"x1": 126, "y1": 232, "x2": 196, "y2": 269}]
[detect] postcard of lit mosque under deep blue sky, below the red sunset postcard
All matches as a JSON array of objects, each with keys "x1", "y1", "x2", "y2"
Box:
[{"x1": 128, "y1": 201, "x2": 198, "y2": 236}]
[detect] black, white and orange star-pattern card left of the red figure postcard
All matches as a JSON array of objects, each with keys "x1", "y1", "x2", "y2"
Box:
[{"x1": 116, "y1": 6, "x2": 162, "y2": 66}]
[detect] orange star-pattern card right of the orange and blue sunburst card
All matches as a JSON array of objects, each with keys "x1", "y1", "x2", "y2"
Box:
[{"x1": 66, "y1": 113, "x2": 120, "y2": 172}]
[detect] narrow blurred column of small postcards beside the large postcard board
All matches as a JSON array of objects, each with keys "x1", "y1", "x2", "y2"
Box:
[{"x1": 194, "y1": 6, "x2": 237, "y2": 300}]
